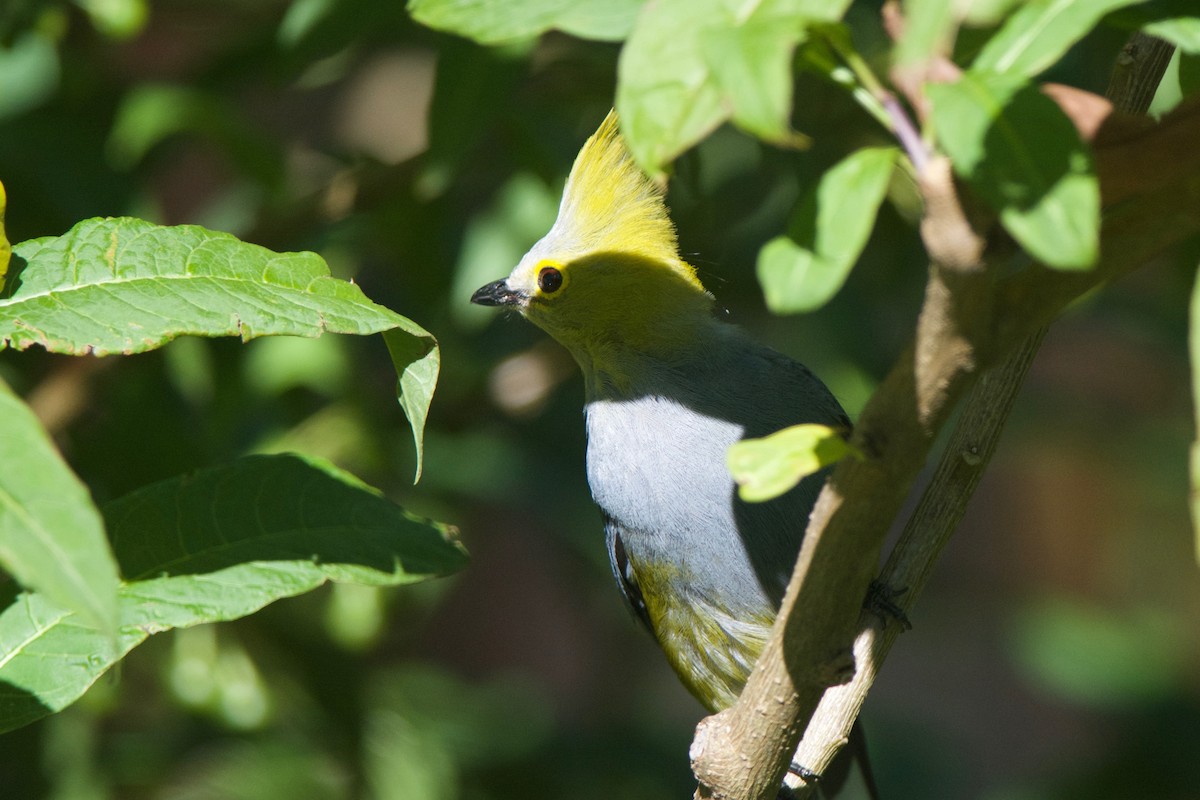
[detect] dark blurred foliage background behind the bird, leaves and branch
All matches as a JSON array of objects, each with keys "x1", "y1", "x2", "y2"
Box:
[{"x1": 0, "y1": 0, "x2": 1200, "y2": 800}]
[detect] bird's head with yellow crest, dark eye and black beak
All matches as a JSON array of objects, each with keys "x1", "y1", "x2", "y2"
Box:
[{"x1": 470, "y1": 113, "x2": 713, "y2": 369}]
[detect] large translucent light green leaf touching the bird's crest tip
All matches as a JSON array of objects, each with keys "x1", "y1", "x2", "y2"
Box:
[{"x1": 617, "y1": 0, "x2": 848, "y2": 174}]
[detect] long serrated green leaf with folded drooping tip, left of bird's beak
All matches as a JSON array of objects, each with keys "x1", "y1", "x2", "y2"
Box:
[{"x1": 0, "y1": 217, "x2": 438, "y2": 470}]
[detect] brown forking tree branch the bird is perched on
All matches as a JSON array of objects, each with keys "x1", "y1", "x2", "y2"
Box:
[{"x1": 692, "y1": 28, "x2": 1200, "y2": 800}]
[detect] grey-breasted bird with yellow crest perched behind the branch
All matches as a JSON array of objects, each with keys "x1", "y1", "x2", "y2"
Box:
[{"x1": 470, "y1": 110, "x2": 878, "y2": 796}]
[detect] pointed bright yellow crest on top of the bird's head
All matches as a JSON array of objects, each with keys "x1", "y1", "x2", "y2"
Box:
[{"x1": 547, "y1": 110, "x2": 703, "y2": 290}]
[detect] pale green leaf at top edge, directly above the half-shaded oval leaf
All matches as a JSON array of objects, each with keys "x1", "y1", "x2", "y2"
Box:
[{"x1": 971, "y1": 0, "x2": 1145, "y2": 78}]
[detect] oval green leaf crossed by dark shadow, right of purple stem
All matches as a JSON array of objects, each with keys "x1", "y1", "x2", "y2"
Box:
[{"x1": 928, "y1": 72, "x2": 1100, "y2": 270}]
